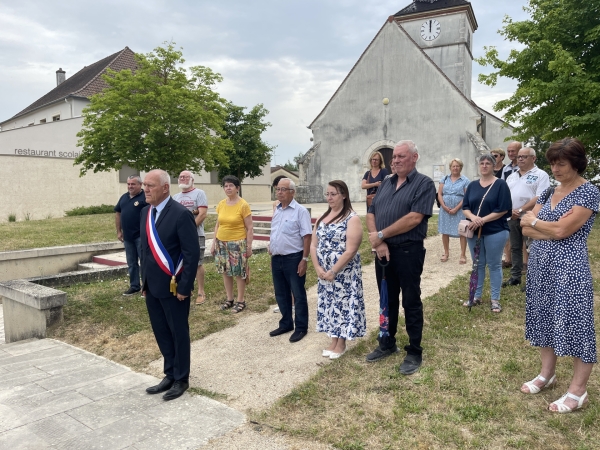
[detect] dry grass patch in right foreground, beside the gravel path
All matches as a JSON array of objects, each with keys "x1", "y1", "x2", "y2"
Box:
[{"x1": 251, "y1": 220, "x2": 600, "y2": 449}]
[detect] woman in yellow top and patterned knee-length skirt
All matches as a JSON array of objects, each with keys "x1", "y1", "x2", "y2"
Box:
[{"x1": 210, "y1": 175, "x2": 254, "y2": 313}]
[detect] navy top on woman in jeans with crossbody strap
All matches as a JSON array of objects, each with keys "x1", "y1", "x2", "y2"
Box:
[{"x1": 463, "y1": 179, "x2": 512, "y2": 236}]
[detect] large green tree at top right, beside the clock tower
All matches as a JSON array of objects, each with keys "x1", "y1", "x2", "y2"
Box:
[{"x1": 477, "y1": 0, "x2": 600, "y2": 150}]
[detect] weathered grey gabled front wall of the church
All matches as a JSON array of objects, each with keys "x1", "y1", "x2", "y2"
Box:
[{"x1": 308, "y1": 23, "x2": 479, "y2": 201}]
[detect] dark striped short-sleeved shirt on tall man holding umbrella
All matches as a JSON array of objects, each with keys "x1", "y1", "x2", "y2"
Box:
[{"x1": 369, "y1": 169, "x2": 435, "y2": 245}]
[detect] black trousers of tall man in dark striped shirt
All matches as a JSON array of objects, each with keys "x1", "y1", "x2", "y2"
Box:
[{"x1": 375, "y1": 242, "x2": 425, "y2": 355}]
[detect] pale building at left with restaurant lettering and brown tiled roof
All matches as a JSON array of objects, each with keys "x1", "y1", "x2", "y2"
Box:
[{"x1": 0, "y1": 47, "x2": 271, "y2": 222}]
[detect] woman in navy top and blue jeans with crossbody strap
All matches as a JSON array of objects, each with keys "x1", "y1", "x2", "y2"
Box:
[{"x1": 463, "y1": 153, "x2": 512, "y2": 313}]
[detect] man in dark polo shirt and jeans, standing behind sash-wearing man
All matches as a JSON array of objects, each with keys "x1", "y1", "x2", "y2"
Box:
[{"x1": 115, "y1": 175, "x2": 147, "y2": 296}]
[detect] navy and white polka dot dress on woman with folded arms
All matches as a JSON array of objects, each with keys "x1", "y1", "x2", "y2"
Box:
[{"x1": 525, "y1": 183, "x2": 600, "y2": 363}]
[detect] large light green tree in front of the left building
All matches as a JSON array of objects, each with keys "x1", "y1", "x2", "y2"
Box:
[{"x1": 75, "y1": 42, "x2": 232, "y2": 175}]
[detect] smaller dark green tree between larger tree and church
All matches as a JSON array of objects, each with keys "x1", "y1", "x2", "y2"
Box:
[{"x1": 219, "y1": 102, "x2": 275, "y2": 191}]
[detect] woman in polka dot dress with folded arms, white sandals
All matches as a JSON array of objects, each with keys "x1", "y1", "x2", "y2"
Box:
[{"x1": 521, "y1": 138, "x2": 600, "y2": 413}]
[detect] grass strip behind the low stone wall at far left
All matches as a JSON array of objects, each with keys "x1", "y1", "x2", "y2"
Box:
[{"x1": 0, "y1": 213, "x2": 217, "y2": 252}]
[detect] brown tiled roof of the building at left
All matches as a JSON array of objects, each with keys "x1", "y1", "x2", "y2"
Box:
[{"x1": 8, "y1": 47, "x2": 136, "y2": 120}]
